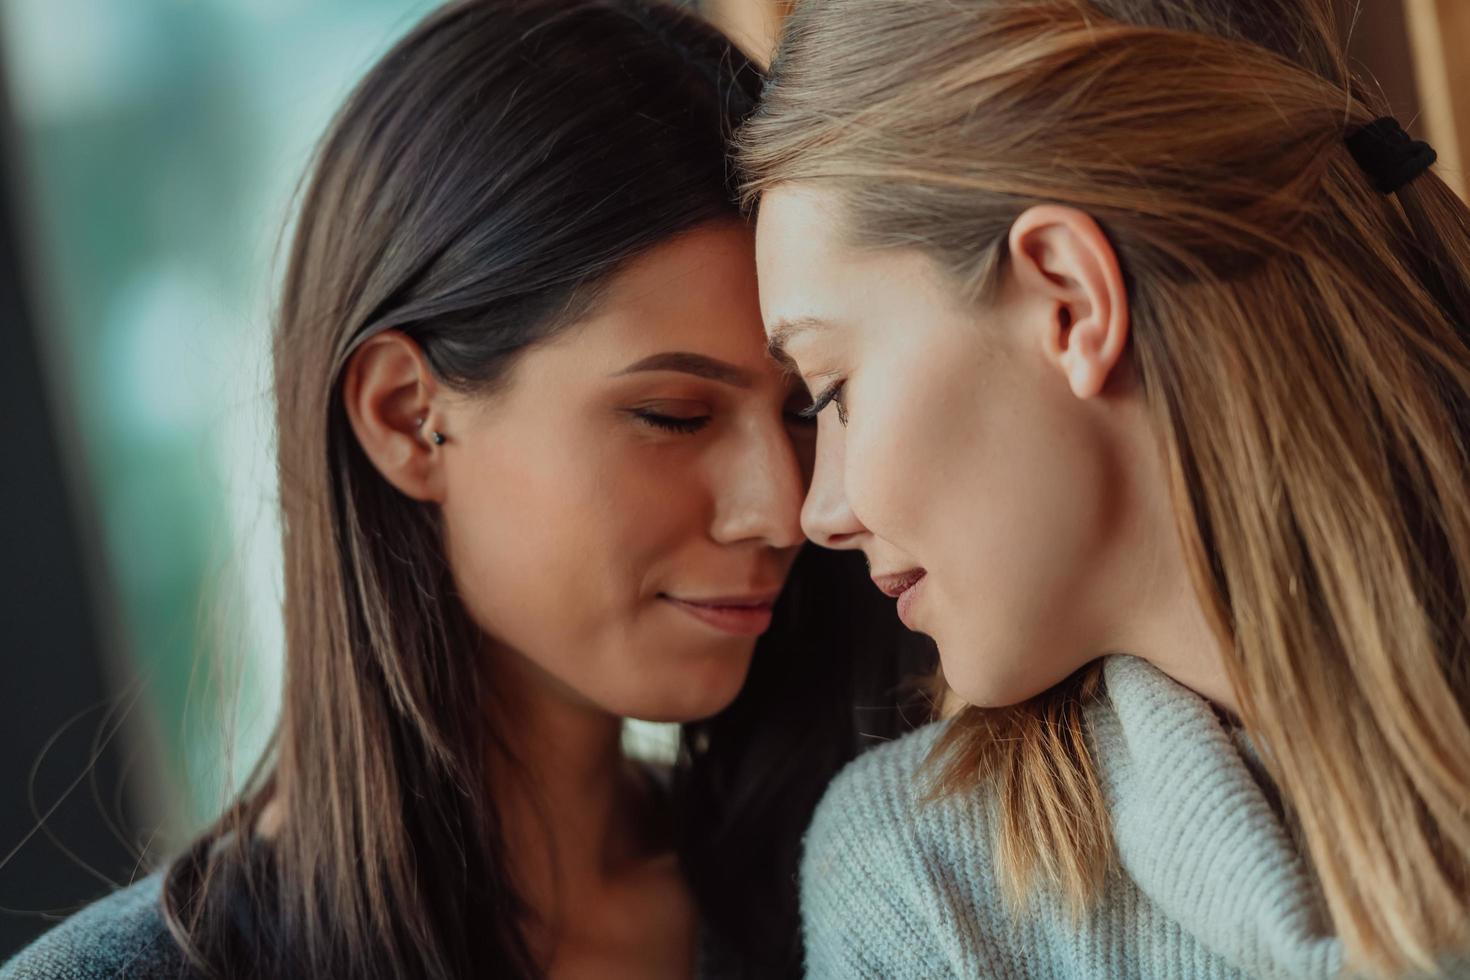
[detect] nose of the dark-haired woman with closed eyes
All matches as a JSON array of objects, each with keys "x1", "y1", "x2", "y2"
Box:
[{"x1": 711, "y1": 417, "x2": 804, "y2": 548}]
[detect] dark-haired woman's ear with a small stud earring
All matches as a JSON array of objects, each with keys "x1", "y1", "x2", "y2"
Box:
[{"x1": 343, "y1": 331, "x2": 444, "y2": 502}]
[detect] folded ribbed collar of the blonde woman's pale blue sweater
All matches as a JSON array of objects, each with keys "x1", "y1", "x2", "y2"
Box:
[{"x1": 1089, "y1": 657, "x2": 1342, "y2": 977}]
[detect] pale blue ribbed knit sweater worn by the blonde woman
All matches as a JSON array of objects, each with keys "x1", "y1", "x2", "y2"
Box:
[{"x1": 801, "y1": 657, "x2": 1470, "y2": 980}]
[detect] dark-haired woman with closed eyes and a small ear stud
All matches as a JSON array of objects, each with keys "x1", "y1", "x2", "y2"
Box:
[{"x1": 3, "y1": 0, "x2": 917, "y2": 979}]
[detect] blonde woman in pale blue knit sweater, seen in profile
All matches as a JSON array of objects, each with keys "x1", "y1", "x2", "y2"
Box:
[{"x1": 742, "y1": 0, "x2": 1470, "y2": 980}]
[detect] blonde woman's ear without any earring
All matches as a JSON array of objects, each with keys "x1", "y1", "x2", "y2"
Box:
[{"x1": 1008, "y1": 204, "x2": 1129, "y2": 398}]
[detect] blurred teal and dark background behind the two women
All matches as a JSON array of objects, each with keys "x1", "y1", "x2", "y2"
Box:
[{"x1": 0, "y1": 0, "x2": 1470, "y2": 961}]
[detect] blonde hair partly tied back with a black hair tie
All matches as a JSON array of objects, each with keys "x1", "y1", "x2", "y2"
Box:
[{"x1": 739, "y1": 0, "x2": 1470, "y2": 974}]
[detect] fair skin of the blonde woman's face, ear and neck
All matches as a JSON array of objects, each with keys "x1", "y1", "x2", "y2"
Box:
[{"x1": 757, "y1": 181, "x2": 1236, "y2": 711}]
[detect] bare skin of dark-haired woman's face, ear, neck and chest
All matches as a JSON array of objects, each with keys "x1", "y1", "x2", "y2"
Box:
[{"x1": 344, "y1": 222, "x2": 813, "y2": 980}]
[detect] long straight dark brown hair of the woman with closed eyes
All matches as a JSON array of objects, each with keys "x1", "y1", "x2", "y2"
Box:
[{"x1": 166, "y1": 0, "x2": 929, "y2": 979}]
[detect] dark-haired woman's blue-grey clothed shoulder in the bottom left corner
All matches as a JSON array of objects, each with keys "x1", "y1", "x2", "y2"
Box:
[{"x1": 0, "y1": 873, "x2": 185, "y2": 980}]
